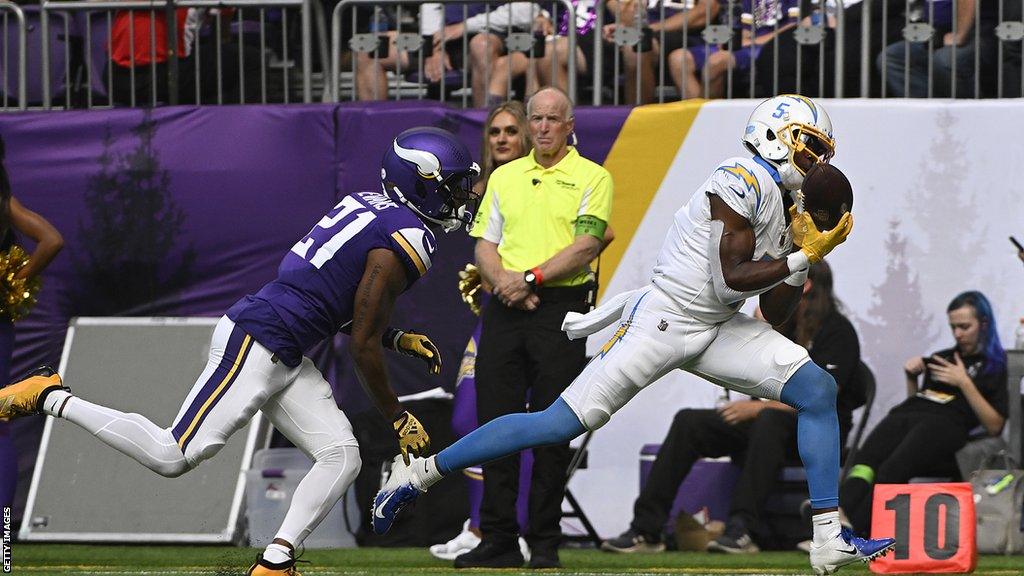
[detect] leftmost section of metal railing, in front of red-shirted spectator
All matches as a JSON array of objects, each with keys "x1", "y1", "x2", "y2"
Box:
[{"x1": 0, "y1": 0, "x2": 313, "y2": 110}]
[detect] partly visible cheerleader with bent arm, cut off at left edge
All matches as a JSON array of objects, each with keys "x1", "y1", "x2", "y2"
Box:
[{"x1": 0, "y1": 133, "x2": 63, "y2": 506}]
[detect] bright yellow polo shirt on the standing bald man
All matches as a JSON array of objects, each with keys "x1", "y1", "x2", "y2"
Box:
[{"x1": 469, "y1": 147, "x2": 612, "y2": 286}]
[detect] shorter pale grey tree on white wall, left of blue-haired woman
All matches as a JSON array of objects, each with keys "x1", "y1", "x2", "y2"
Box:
[{"x1": 854, "y1": 219, "x2": 937, "y2": 422}]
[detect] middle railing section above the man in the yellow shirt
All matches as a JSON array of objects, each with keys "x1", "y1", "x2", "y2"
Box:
[{"x1": 325, "y1": 0, "x2": 578, "y2": 107}]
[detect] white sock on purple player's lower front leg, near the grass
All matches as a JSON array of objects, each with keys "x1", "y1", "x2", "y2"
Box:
[{"x1": 274, "y1": 446, "x2": 360, "y2": 545}]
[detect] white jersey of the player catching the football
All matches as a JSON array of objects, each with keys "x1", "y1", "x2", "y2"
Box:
[{"x1": 651, "y1": 158, "x2": 793, "y2": 324}]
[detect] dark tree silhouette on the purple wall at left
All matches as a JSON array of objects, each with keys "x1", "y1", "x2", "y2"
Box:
[{"x1": 74, "y1": 114, "x2": 196, "y2": 316}]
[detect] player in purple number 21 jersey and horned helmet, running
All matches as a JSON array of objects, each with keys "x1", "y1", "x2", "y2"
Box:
[{"x1": 0, "y1": 128, "x2": 480, "y2": 576}]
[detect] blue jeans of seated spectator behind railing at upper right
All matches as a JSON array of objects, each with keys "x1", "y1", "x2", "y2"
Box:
[{"x1": 876, "y1": 41, "x2": 975, "y2": 98}]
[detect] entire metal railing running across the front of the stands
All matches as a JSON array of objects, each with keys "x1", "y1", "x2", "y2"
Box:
[{"x1": 0, "y1": 0, "x2": 1024, "y2": 110}]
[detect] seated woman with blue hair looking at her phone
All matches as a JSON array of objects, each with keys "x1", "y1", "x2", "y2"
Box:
[{"x1": 840, "y1": 290, "x2": 1009, "y2": 533}]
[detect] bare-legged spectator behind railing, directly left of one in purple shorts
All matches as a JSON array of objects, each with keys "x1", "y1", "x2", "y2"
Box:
[{"x1": 602, "y1": 0, "x2": 720, "y2": 105}]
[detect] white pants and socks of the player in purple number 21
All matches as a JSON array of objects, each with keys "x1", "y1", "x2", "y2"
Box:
[{"x1": 57, "y1": 317, "x2": 361, "y2": 547}]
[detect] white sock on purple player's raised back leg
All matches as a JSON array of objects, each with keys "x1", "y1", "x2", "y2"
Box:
[{"x1": 56, "y1": 390, "x2": 188, "y2": 478}]
